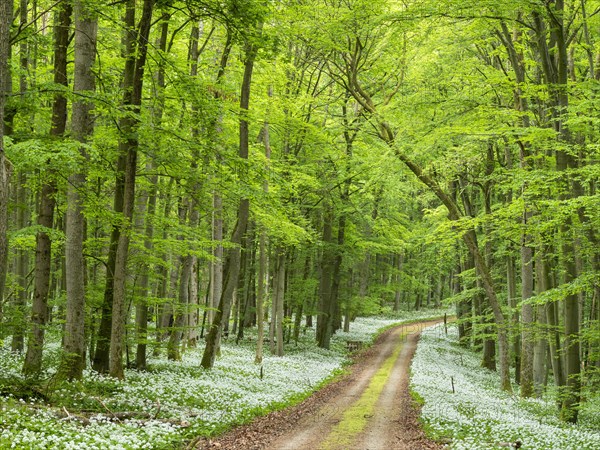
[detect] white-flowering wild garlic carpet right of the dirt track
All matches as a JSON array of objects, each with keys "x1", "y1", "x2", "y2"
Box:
[{"x1": 411, "y1": 325, "x2": 600, "y2": 450}]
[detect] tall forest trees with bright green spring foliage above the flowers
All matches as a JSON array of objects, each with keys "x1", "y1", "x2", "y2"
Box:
[{"x1": 0, "y1": 0, "x2": 600, "y2": 446}]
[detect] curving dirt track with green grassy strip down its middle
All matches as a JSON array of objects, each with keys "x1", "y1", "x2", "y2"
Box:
[{"x1": 193, "y1": 321, "x2": 444, "y2": 450}]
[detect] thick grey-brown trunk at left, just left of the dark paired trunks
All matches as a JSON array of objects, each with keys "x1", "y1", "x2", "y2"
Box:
[{"x1": 59, "y1": 0, "x2": 98, "y2": 379}]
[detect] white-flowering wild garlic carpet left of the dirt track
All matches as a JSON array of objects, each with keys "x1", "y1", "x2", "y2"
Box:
[{"x1": 0, "y1": 310, "x2": 444, "y2": 450}]
